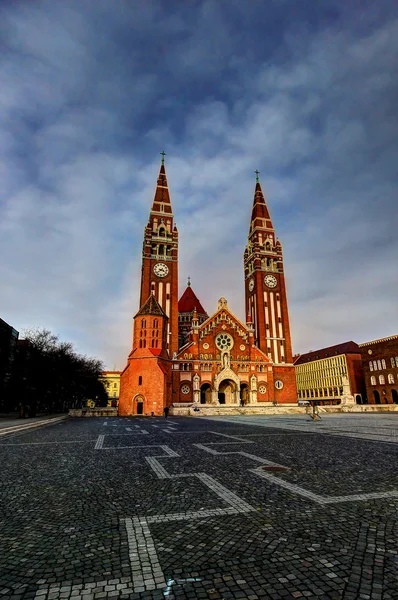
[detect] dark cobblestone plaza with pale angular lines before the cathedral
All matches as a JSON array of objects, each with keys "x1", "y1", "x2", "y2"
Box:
[{"x1": 0, "y1": 414, "x2": 398, "y2": 600}]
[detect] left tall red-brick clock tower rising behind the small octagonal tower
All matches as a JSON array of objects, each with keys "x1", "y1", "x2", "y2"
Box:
[{"x1": 140, "y1": 153, "x2": 178, "y2": 358}]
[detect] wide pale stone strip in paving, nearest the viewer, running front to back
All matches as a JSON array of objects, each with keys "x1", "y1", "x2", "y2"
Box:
[{"x1": 124, "y1": 518, "x2": 167, "y2": 593}]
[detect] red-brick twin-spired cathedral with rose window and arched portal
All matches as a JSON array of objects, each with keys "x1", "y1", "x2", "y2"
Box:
[{"x1": 119, "y1": 156, "x2": 297, "y2": 416}]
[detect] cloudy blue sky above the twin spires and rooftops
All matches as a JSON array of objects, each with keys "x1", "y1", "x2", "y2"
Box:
[{"x1": 0, "y1": 0, "x2": 398, "y2": 369}]
